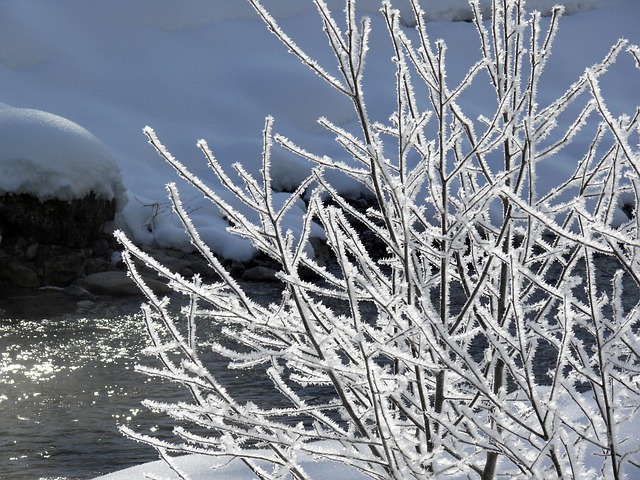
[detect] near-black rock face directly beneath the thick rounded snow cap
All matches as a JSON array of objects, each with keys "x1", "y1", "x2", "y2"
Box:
[{"x1": 0, "y1": 193, "x2": 116, "y2": 247}]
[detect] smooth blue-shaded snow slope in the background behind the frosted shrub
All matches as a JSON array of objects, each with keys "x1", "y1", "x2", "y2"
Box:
[{"x1": 0, "y1": 0, "x2": 640, "y2": 259}]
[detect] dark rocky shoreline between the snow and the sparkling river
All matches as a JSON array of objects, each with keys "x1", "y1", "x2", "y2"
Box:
[{"x1": 0, "y1": 191, "x2": 384, "y2": 296}]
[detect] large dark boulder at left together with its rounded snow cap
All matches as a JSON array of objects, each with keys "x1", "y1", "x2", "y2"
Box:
[{"x1": 0, "y1": 105, "x2": 127, "y2": 287}]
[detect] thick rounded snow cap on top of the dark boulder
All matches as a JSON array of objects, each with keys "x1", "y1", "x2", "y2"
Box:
[{"x1": 0, "y1": 104, "x2": 126, "y2": 208}]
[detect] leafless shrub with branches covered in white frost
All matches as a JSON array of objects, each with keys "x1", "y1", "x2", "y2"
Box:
[{"x1": 119, "y1": 0, "x2": 640, "y2": 479}]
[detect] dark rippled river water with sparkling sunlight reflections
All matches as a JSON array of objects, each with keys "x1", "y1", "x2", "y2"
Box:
[{"x1": 0, "y1": 256, "x2": 638, "y2": 480}]
